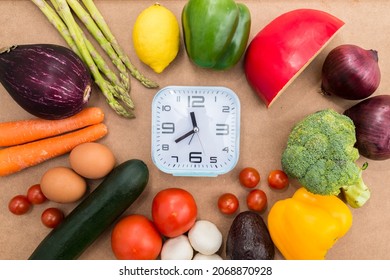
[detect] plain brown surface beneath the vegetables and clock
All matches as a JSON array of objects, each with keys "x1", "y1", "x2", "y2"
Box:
[{"x1": 0, "y1": 0, "x2": 390, "y2": 259}]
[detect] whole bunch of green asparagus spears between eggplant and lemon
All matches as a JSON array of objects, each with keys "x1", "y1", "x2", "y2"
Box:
[{"x1": 31, "y1": 0, "x2": 158, "y2": 118}]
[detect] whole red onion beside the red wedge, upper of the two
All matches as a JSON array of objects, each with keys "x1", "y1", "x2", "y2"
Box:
[{"x1": 321, "y1": 45, "x2": 381, "y2": 100}]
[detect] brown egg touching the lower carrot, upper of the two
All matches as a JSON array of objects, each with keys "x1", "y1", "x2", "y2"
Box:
[{"x1": 69, "y1": 142, "x2": 115, "y2": 179}]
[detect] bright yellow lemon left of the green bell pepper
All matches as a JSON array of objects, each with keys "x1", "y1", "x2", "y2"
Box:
[{"x1": 133, "y1": 3, "x2": 180, "y2": 73}]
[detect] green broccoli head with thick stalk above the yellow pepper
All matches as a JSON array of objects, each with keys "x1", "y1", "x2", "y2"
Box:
[{"x1": 282, "y1": 109, "x2": 370, "y2": 208}]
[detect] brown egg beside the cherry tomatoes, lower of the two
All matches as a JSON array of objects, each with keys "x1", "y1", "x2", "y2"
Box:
[{"x1": 40, "y1": 167, "x2": 87, "y2": 203}]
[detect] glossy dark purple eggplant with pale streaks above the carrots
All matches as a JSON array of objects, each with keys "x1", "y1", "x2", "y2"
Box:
[{"x1": 0, "y1": 44, "x2": 92, "y2": 119}]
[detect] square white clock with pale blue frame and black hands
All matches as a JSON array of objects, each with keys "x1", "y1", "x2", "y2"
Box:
[{"x1": 152, "y1": 86, "x2": 240, "y2": 176}]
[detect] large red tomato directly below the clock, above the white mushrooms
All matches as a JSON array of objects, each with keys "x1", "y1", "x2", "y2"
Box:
[{"x1": 152, "y1": 188, "x2": 198, "y2": 237}]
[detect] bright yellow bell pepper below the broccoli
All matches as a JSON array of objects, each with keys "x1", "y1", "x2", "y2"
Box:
[{"x1": 268, "y1": 187, "x2": 352, "y2": 260}]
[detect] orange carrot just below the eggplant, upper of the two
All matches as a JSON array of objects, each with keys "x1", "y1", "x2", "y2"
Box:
[{"x1": 0, "y1": 107, "x2": 104, "y2": 147}]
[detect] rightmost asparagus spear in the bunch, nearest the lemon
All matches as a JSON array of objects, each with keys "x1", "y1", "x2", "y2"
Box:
[{"x1": 82, "y1": 0, "x2": 158, "y2": 88}]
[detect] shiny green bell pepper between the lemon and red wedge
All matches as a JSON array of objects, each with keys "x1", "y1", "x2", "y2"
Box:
[{"x1": 182, "y1": 0, "x2": 251, "y2": 70}]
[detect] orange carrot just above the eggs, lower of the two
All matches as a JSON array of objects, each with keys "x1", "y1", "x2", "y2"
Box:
[{"x1": 0, "y1": 123, "x2": 108, "y2": 176}]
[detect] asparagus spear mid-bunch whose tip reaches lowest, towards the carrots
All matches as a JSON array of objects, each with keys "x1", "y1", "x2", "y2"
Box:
[{"x1": 51, "y1": 0, "x2": 134, "y2": 118}]
